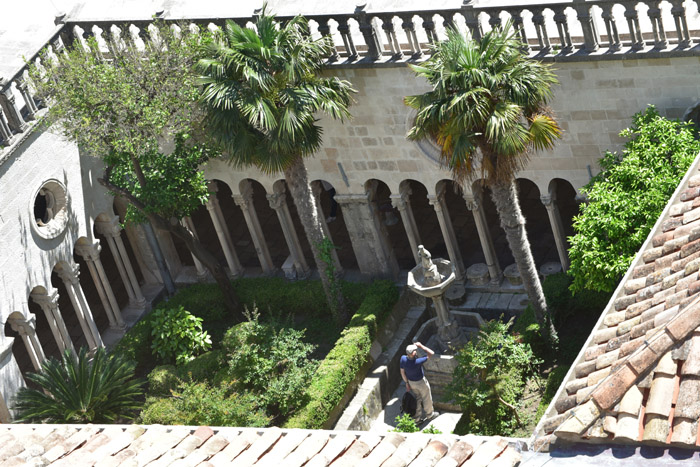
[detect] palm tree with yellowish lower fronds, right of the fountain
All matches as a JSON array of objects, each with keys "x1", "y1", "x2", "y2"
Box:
[{"x1": 404, "y1": 23, "x2": 561, "y2": 338}]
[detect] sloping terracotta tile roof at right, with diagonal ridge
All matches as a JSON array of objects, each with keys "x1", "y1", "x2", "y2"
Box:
[{"x1": 540, "y1": 158, "x2": 700, "y2": 448}]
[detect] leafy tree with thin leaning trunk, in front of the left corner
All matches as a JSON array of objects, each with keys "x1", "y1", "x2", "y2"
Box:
[{"x1": 31, "y1": 21, "x2": 238, "y2": 311}]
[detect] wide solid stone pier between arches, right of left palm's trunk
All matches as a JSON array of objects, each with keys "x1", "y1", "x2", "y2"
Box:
[{"x1": 335, "y1": 192, "x2": 399, "y2": 278}]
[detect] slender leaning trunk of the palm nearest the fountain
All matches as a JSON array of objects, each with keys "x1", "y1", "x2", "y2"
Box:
[{"x1": 489, "y1": 180, "x2": 557, "y2": 341}]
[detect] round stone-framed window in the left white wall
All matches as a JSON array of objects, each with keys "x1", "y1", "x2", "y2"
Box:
[{"x1": 31, "y1": 180, "x2": 68, "y2": 239}]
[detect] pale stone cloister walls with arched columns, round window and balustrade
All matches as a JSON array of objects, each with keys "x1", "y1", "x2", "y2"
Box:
[{"x1": 0, "y1": 0, "x2": 700, "y2": 436}]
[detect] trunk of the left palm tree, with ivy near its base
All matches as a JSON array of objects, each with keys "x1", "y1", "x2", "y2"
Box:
[{"x1": 284, "y1": 156, "x2": 348, "y2": 324}]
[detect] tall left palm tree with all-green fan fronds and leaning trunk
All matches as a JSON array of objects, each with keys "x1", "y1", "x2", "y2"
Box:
[{"x1": 197, "y1": 8, "x2": 355, "y2": 319}]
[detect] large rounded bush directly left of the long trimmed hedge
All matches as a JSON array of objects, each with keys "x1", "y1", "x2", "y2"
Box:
[{"x1": 222, "y1": 310, "x2": 318, "y2": 418}]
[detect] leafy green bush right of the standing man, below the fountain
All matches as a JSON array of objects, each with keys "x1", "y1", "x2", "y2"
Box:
[{"x1": 448, "y1": 320, "x2": 540, "y2": 436}]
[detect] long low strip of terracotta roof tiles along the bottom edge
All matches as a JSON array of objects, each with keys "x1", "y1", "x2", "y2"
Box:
[{"x1": 0, "y1": 425, "x2": 521, "y2": 467}]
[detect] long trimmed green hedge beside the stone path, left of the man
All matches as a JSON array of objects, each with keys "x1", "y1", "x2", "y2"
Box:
[{"x1": 284, "y1": 281, "x2": 399, "y2": 429}]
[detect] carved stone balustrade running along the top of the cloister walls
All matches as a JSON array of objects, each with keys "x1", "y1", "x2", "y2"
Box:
[{"x1": 0, "y1": 0, "x2": 700, "y2": 148}]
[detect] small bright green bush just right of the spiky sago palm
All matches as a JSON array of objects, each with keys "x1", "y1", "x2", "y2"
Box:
[{"x1": 150, "y1": 306, "x2": 211, "y2": 365}]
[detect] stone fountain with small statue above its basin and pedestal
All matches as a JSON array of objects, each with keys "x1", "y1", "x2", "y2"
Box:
[{"x1": 408, "y1": 245, "x2": 466, "y2": 350}]
